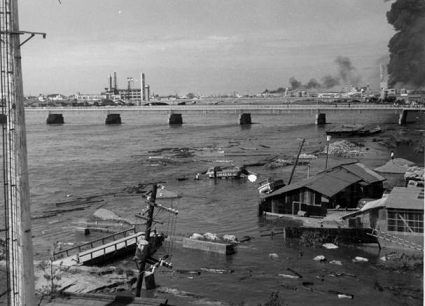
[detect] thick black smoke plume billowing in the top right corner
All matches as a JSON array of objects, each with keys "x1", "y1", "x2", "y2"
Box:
[{"x1": 387, "y1": 0, "x2": 425, "y2": 87}]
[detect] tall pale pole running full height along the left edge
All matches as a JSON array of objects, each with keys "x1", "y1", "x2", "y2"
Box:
[{"x1": 0, "y1": 0, "x2": 45, "y2": 306}]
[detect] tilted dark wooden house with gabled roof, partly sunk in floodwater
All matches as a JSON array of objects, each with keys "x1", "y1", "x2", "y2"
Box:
[{"x1": 259, "y1": 163, "x2": 385, "y2": 216}]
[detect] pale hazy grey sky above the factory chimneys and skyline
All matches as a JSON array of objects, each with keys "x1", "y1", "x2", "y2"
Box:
[{"x1": 18, "y1": 0, "x2": 395, "y2": 95}]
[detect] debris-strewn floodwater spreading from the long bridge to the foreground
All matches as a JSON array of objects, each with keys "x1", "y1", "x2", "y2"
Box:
[{"x1": 0, "y1": 112, "x2": 424, "y2": 306}]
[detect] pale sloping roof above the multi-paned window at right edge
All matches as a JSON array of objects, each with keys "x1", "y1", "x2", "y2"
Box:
[{"x1": 385, "y1": 187, "x2": 424, "y2": 210}]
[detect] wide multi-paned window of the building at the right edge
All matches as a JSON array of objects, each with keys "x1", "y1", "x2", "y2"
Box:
[{"x1": 387, "y1": 209, "x2": 424, "y2": 233}]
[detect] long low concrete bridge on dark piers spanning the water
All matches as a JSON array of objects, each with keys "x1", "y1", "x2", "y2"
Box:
[{"x1": 26, "y1": 104, "x2": 425, "y2": 125}]
